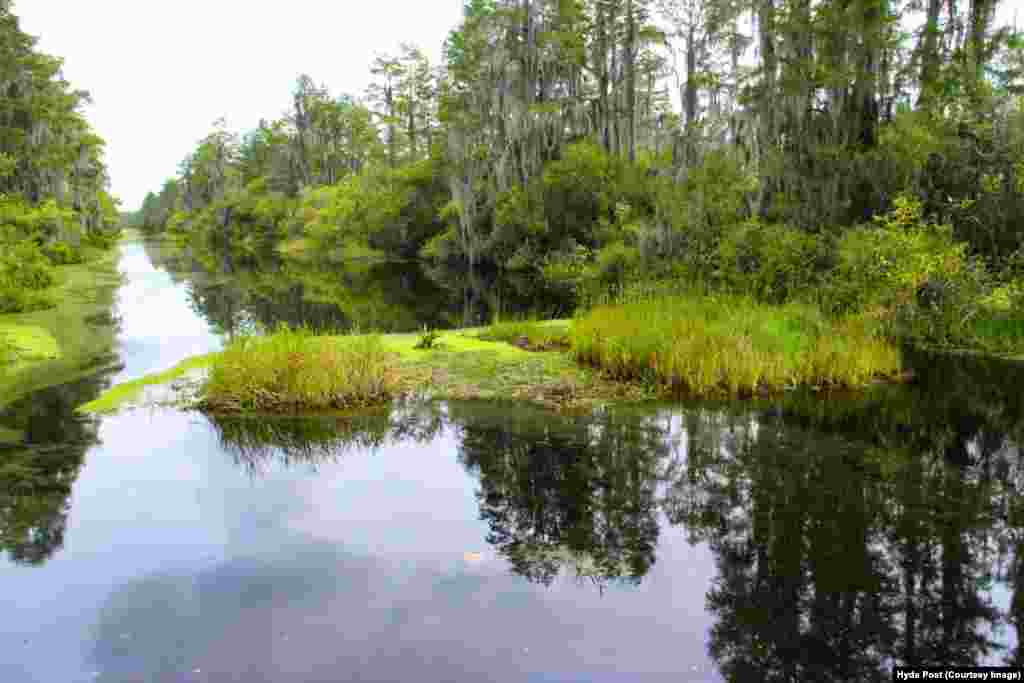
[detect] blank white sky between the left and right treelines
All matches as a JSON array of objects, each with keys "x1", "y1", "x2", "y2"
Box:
[{"x1": 14, "y1": 0, "x2": 463, "y2": 210}]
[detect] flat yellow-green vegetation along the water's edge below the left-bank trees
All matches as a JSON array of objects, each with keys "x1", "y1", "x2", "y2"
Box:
[{"x1": 0, "y1": 248, "x2": 121, "y2": 405}]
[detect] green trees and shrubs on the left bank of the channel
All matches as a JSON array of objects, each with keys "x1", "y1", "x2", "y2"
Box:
[{"x1": 0, "y1": 0, "x2": 120, "y2": 313}]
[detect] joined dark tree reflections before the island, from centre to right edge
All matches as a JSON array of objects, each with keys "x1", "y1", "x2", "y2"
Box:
[{"x1": 193, "y1": 356, "x2": 1024, "y2": 681}]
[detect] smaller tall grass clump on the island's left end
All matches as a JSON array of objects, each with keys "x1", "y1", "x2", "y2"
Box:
[{"x1": 203, "y1": 326, "x2": 397, "y2": 413}]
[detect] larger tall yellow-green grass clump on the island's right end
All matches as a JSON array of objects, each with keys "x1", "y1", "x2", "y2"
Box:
[{"x1": 570, "y1": 294, "x2": 900, "y2": 396}]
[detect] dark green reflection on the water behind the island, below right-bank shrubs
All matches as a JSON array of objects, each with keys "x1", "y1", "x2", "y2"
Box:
[{"x1": 145, "y1": 241, "x2": 569, "y2": 334}]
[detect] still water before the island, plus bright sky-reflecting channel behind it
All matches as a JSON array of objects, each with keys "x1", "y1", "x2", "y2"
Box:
[{"x1": 0, "y1": 237, "x2": 1024, "y2": 683}]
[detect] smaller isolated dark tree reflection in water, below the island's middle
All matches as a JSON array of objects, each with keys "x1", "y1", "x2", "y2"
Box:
[{"x1": 452, "y1": 405, "x2": 670, "y2": 586}]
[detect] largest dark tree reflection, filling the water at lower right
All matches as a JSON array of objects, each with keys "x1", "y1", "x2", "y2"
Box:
[{"x1": 666, "y1": 350, "x2": 1024, "y2": 681}]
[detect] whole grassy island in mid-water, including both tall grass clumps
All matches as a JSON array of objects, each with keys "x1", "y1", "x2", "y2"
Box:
[{"x1": 83, "y1": 290, "x2": 901, "y2": 413}]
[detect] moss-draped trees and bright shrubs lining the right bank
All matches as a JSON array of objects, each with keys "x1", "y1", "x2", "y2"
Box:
[{"x1": 140, "y1": 0, "x2": 1024, "y2": 339}]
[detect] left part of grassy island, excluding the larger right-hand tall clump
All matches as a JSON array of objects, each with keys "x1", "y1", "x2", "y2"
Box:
[{"x1": 81, "y1": 321, "x2": 652, "y2": 415}]
